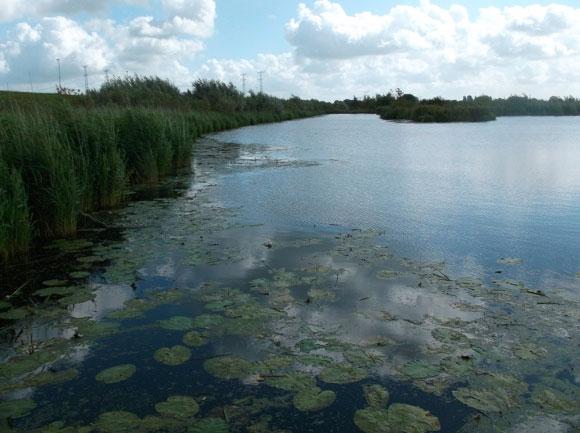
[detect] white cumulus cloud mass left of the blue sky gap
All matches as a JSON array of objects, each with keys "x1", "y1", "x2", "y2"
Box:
[{"x1": 0, "y1": 0, "x2": 216, "y2": 90}]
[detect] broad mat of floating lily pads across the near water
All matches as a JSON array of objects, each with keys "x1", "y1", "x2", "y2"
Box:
[{"x1": 0, "y1": 140, "x2": 580, "y2": 433}]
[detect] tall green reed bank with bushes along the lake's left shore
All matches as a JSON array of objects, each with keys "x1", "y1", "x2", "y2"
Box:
[{"x1": 0, "y1": 77, "x2": 336, "y2": 262}]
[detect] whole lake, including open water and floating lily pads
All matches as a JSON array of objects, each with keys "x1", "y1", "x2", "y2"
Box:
[{"x1": 0, "y1": 115, "x2": 580, "y2": 433}]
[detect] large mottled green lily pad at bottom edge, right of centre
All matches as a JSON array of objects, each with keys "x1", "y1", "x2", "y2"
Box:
[{"x1": 354, "y1": 403, "x2": 441, "y2": 433}]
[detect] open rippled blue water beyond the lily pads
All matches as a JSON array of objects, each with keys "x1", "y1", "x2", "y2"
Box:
[{"x1": 216, "y1": 115, "x2": 580, "y2": 286}]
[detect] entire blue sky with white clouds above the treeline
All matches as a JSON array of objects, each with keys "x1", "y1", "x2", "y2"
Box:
[{"x1": 0, "y1": 0, "x2": 580, "y2": 100}]
